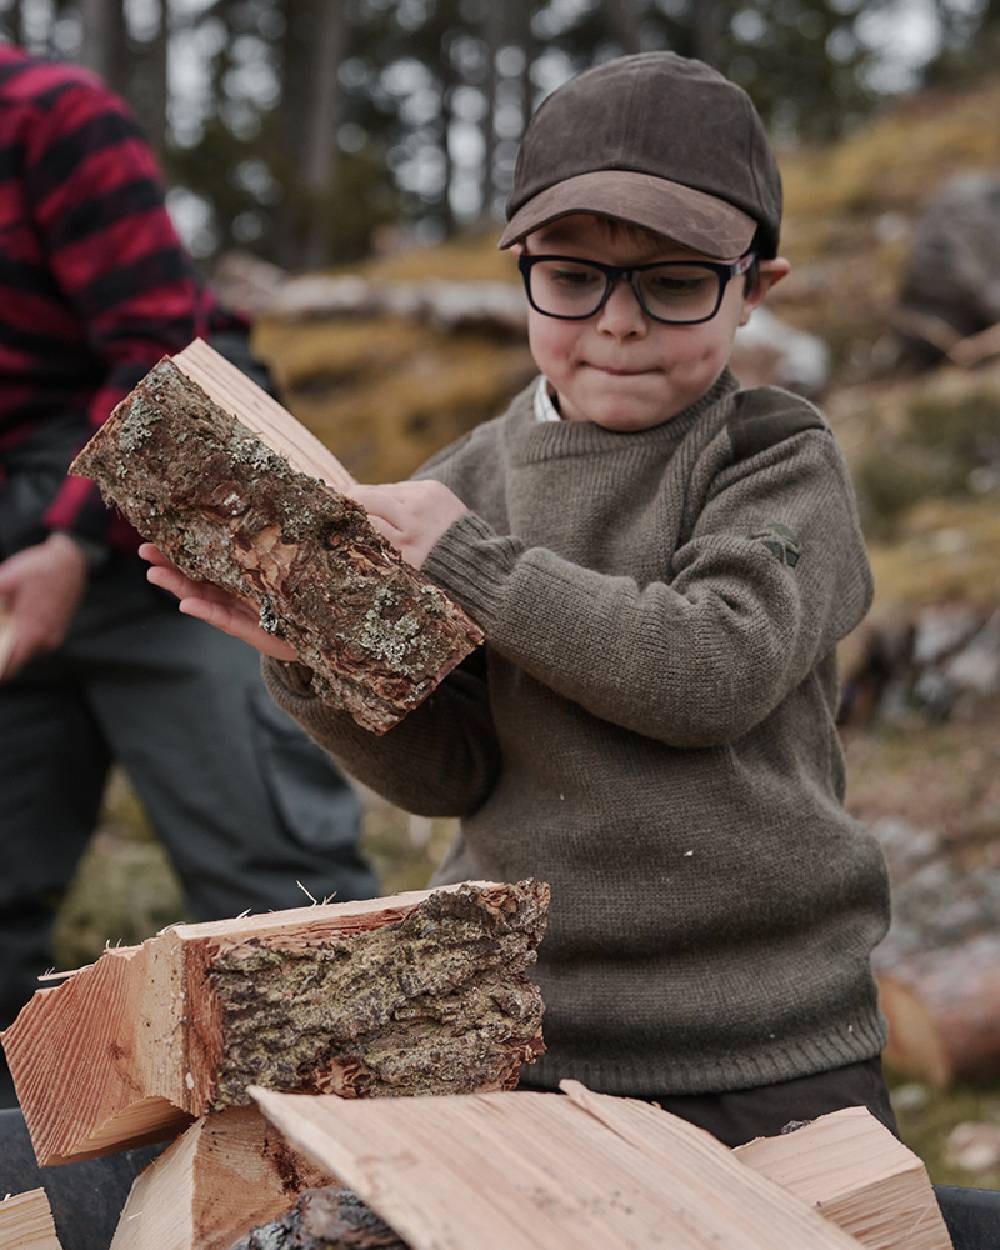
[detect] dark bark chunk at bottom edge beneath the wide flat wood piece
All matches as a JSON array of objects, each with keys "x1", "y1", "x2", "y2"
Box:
[{"x1": 233, "y1": 1185, "x2": 408, "y2": 1250}]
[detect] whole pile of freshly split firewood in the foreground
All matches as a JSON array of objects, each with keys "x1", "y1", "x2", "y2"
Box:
[{"x1": 0, "y1": 881, "x2": 950, "y2": 1250}]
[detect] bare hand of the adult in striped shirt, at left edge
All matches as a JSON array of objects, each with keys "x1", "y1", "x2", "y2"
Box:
[{"x1": 0, "y1": 534, "x2": 86, "y2": 681}]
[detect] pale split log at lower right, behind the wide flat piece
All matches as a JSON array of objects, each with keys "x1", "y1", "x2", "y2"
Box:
[{"x1": 735, "y1": 1106, "x2": 951, "y2": 1250}]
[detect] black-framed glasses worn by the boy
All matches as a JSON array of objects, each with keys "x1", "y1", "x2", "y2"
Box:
[{"x1": 518, "y1": 251, "x2": 755, "y2": 325}]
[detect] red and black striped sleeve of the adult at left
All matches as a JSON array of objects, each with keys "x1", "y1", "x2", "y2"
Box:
[{"x1": 25, "y1": 79, "x2": 213, "y2": 541}]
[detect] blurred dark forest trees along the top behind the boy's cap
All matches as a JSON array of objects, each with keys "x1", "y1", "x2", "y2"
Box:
[{"x1": 0, "y1": 0, "x2": 1000, "y2": 269}]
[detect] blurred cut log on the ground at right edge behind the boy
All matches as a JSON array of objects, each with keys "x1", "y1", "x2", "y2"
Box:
[{"x1": 879, "y1": 933, "x2": 1000, "y2": 1089}]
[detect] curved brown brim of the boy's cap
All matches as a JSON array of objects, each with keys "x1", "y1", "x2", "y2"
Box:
[{"x1": 498, "y1": 169, "x2": 756, "y2": 260}]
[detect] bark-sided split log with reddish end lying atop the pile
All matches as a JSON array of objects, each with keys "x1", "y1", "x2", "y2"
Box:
[{"x1": 3, "y1": 881, "x2": 549, "y2": 1166}]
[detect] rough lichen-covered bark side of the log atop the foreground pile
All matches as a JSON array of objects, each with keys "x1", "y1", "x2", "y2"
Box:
[{"x1": 206, "y1": 881, "x2": 549, "y2": 1109}]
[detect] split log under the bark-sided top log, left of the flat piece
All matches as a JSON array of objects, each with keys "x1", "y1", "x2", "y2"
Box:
[{"x1": 110, "y1": 1106, "x2": 331, "y2": 1250}]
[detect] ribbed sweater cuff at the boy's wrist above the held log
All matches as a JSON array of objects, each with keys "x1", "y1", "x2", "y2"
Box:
[{"x1": 420, "y1": 513, "x2": 524, "y2": 638}]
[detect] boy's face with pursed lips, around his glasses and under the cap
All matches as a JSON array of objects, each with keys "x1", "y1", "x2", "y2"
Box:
[{"x1": 514, "y1": 213, "x2": 789, "y2": 433}]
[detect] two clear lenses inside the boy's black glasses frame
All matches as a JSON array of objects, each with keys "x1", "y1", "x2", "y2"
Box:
[{"x1": 530, "y1": 260, "x2": 721, "y2": 323}]
